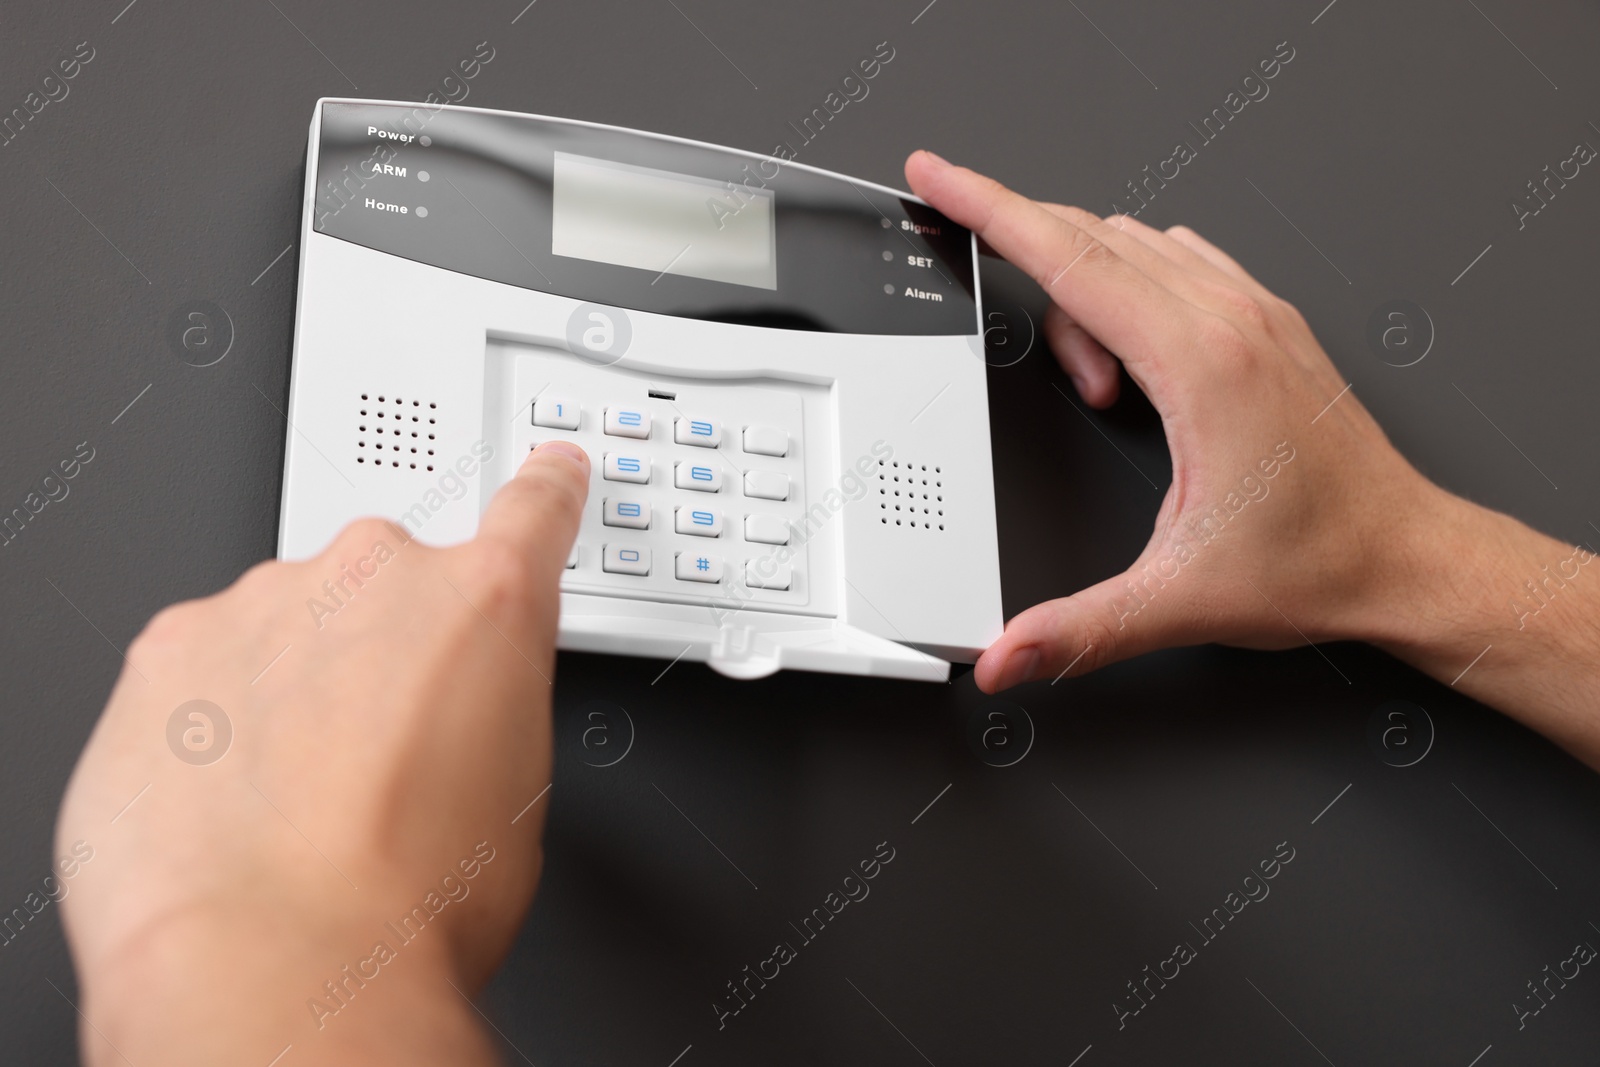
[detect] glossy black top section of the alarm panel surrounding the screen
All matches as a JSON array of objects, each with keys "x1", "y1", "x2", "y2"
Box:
[{"x1": 314, "y1": 104, "x2": 978, "y2": 336}]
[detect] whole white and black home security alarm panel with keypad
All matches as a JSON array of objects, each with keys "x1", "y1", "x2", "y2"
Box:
[{"x1": 278, "y1": 99, "x2": 1002, "y2": 680}]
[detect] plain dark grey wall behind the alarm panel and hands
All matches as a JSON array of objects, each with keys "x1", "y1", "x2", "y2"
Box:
[{"x1": 0, "y1": 0, "x2": 1600, "y2": 1067}]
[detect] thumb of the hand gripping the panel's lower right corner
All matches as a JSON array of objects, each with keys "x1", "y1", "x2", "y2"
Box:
[{"x1": 973, "y1": 563, "x2": 1192, "y2": 693}]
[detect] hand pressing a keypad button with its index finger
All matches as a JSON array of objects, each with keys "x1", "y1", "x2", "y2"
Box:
[{"x1": 56, "y1": 443, "x2": 589, "y2": 1064}]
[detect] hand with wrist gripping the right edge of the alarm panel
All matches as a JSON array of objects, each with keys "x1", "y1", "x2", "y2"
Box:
[{"x1": 906, "y1": 152, "x2": 1600, "y2": 766}]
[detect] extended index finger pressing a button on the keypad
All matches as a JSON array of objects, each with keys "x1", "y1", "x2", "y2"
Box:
[{"x1": 478, "y1": 442, "x2": 589, "y2": 576}]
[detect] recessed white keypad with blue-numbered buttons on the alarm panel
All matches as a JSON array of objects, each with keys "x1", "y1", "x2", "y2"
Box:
[{"x1": 517, "y1": 373, "x2": 814, "y2": 609}]
